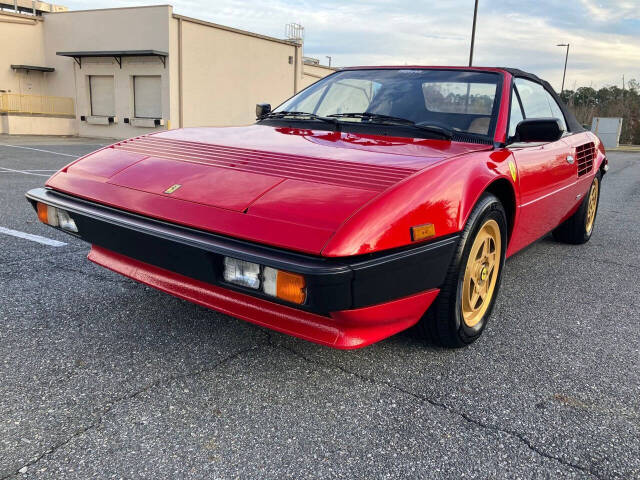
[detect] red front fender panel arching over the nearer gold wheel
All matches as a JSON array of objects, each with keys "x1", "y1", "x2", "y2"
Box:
[{"x1": 322, "y1": 150, "x2": 517, "y2": 257}]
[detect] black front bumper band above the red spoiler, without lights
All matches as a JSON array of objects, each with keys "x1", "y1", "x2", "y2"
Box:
[{"x1": 26, "y1": 188, "x2": 458, "y2": 314}]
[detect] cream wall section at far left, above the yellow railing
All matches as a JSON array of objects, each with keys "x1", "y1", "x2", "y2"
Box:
[{"x1": 0, "y1": 11, "x2": 47, "y2": 95}]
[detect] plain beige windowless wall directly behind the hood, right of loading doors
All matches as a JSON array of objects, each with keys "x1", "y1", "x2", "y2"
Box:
[{"x1": 174, "y1": 17, "x2": 302, "y2": 127}]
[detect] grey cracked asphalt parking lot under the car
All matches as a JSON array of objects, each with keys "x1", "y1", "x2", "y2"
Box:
[{"x1": 0, "y1": 135, "x2": 640, "y2": 479}]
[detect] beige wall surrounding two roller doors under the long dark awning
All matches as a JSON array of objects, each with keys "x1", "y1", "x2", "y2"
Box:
[{"x1": 44, "y1": 5, "x2": 172, "y2": 138}]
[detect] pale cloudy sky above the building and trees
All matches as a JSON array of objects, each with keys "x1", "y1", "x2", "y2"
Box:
[{"x1": 61, "y1": 0, "x2": 640, "y2": 90}]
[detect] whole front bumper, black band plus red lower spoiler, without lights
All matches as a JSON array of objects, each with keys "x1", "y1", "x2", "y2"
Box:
[{"x1": 27, "y1": 188, "x2": 458, "y2": 348}]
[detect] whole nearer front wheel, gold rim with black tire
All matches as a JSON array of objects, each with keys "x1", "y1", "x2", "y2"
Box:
[{"x1": 417, "y1": 193, "x2": 507, "y2": 347}]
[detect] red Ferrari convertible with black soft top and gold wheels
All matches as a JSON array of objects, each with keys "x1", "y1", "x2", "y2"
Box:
[{"x1": 27, "y1": 67, "x2": 607, "y2": 349}]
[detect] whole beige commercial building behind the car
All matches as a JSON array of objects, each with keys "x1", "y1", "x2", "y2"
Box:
[{"x1": 0, "y1": 0, "x2": 333, "y2": 138}]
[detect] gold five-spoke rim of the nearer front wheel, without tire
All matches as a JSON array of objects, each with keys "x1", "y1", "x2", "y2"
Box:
[{"x1": 462, "y1": 220, "x2": 502, "y2": 327}]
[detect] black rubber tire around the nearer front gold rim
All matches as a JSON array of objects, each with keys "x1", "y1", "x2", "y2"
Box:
[{"x1": 416, "y1": 193, "x2": 508, "y2": 348}]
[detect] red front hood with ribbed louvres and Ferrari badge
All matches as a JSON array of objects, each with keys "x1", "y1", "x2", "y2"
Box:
[{"x1": 47, "y1": 125, "x2": 490, "y2": 254}]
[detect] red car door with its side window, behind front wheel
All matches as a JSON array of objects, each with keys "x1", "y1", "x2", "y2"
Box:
[{"x1": 509, "y1": 78, "x2": 577, "y2": 249}]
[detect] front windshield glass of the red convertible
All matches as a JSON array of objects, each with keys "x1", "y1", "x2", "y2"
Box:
[{"x1": 274, "y1": 69, "x2": 500, "y2": 137}]
